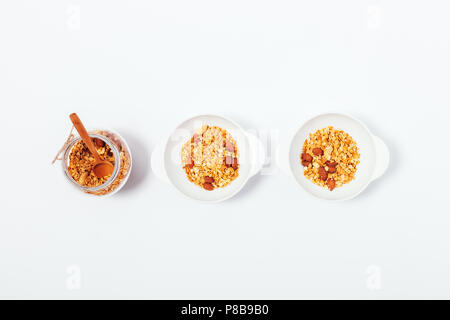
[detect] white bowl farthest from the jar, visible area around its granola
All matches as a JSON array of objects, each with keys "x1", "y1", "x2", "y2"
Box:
[{"x1": 289, "y1": 113, "x2": 389, "y2": 200}]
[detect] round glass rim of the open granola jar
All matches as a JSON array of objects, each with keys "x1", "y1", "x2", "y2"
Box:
[{"x1": 62, "y1": 132, "x2": 121, "y2": 192}]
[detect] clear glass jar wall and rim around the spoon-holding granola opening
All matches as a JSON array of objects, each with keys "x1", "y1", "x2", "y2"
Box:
[{"x1": 62, "y1": 130, "x2": 132, "y2": 196}]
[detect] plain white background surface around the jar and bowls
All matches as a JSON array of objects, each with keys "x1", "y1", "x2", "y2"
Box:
[{"x1": 0, "y1": 0, "x2": 450, "y2": 299}]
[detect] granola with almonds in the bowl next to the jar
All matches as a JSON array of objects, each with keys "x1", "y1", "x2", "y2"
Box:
[{"x1": 181, "y1": 125, "x2": 240, "y2": 191}]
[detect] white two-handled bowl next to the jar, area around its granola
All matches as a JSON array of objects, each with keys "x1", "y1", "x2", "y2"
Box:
[{"x1": 152, "y1": 115, "x2": 265, "y2": 202}]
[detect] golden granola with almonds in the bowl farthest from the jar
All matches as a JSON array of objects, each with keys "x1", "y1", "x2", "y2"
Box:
[{"x1": 300, "y1": 127, "x2": 360, "y2": 191}]
